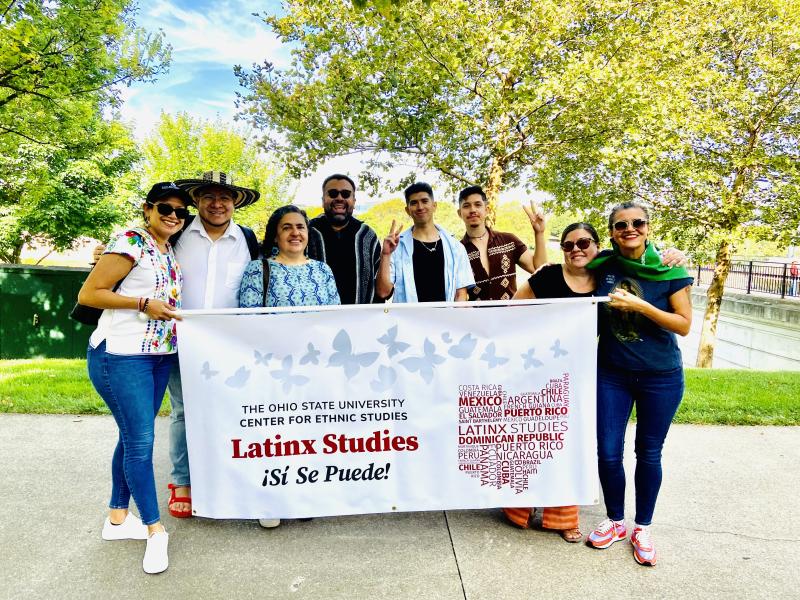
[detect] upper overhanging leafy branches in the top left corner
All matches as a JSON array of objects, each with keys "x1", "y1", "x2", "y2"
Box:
[{"x1": 0, "y1": 0, "x2": 169, "y2": 153}]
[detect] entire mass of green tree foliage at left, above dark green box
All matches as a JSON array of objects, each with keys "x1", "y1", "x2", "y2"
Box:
[{"x1": 0, "y1": 0, "x2": 169, "y2": 262}]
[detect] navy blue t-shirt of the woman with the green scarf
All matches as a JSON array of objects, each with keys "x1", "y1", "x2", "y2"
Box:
[{"x1": 595, "y1": 261, "x2": 694, "y2": 371}]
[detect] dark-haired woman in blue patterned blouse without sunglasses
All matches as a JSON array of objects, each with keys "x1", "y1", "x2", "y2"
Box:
[{"x1": 239, "y1": 204, "x2": 341, "y2": 308}]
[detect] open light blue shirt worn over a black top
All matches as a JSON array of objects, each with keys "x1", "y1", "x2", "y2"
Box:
[{"x1": 390, "y1": 225, "x2": 475, "y2": 302}]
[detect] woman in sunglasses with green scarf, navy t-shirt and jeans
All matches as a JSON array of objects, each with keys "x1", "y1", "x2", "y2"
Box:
[{"x1": 587, "y1": 202, "x2": 692, "y2": 566}]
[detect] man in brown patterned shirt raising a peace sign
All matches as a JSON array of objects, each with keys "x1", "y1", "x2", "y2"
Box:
[{"x1": 458, "y1": 185, "x2": 547, "y2": 300}]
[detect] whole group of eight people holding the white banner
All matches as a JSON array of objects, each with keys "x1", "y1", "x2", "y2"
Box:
[{"x1": 78, "y1": 171, "x2": 692, "y2": 573}]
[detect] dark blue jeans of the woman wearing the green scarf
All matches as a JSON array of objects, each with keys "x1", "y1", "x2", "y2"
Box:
[{"x1": 597, "y1": 367, "x2": 683, "y2": 525}]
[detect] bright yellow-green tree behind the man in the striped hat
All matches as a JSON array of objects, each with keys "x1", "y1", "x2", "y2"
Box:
[{"x1": 142, "y1": 113, "x2": 292, "y2": 237}]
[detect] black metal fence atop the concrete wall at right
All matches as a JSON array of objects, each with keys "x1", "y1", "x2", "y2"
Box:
[{"x1": 690, "y1": 260, "x2": 800, "y2": 298}]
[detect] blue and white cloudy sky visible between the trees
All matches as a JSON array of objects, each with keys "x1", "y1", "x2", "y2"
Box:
[{"x1": 121, "y1": 0, "x2": 538, "y2": 208}]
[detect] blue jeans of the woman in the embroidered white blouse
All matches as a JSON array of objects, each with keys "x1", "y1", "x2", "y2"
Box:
[{"x1": 86, "y1": 341, "x2": 176, "y2": 525}]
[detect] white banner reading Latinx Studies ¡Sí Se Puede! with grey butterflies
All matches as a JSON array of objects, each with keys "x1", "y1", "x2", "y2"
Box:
[{"x1": 178, "y1": 299, "x2": 598, "y2": 519}]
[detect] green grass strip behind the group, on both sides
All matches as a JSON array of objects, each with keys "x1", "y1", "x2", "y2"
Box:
[{"x1": 0, "y1": 359, "x2": 800, "y2": 425}]
